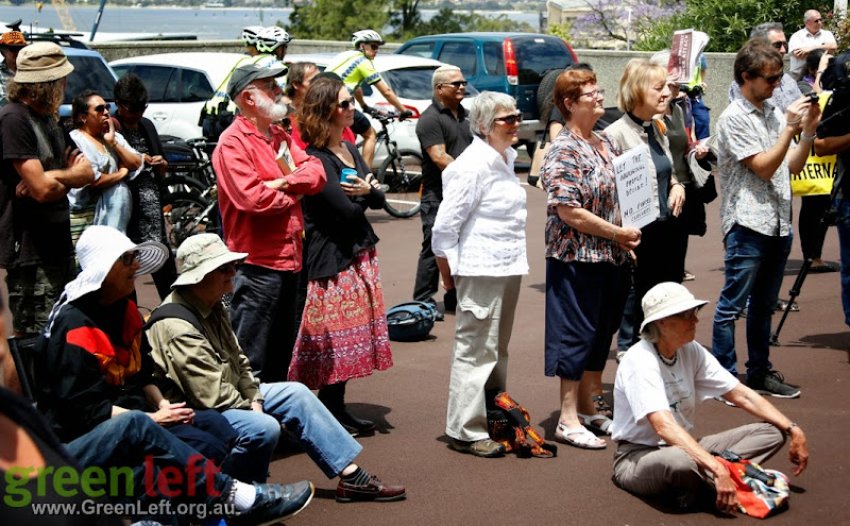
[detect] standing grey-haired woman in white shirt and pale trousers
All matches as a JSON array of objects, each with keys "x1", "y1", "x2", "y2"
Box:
[{"x1": 431, "y1": 91, "x2": 528, "y2": 457}]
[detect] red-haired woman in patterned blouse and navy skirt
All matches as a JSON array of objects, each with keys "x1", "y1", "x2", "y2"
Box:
[{"x1": 540, "y1": 69, "x2": 640, "y2": 449}]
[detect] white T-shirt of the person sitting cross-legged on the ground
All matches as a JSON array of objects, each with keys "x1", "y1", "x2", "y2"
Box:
[{"x1": 611, "y1": 339, "x2": 740, "y2": 447}]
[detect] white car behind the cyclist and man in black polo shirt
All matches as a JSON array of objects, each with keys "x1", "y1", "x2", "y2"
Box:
[{"x1": 284, "y1": 53, "x2": 478, "y2": 167}]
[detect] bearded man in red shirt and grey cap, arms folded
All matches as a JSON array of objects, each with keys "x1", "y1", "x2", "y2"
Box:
[{"x1": 213, "y1": 64, "x2": 326, "y2": 382}]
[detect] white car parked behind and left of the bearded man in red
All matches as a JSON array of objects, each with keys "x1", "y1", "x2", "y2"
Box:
[{"x1": 110, "y1": 52, "x2": 247, "y2": 139}]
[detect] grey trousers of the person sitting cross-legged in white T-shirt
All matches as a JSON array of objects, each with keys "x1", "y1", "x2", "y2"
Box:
[{"x1": 613, "y1": 423, "x2": 785, "y2": 508}]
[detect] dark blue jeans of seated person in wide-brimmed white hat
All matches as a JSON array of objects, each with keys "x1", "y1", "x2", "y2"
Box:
[{"x1": 65, "y1": 411, "x2": 233, "y2": 505}]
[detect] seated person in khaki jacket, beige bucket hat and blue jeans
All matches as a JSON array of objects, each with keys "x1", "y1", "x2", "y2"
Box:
[{"x1": 147, "y1": 234, "x2": 406, "y2": 502}]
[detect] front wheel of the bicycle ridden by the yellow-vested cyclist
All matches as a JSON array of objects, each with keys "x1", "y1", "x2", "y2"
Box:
[{"x1": 375, "y1": 150, "x2": 422, "y2": 217}]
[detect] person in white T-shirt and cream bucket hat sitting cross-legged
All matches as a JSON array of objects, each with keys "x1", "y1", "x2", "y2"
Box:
[{"x1": 612, "y1": 282, "x2": 809, "y2": 513}]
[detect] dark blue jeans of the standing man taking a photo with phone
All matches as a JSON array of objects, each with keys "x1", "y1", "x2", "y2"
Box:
[{"x1": 711, "y1": 225, "x2": 793, "y2": 378}]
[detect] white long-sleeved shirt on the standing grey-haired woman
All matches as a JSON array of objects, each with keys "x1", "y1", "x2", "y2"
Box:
[{"x1": 431, "y1": 137, "x2": 528, "y2": 277}]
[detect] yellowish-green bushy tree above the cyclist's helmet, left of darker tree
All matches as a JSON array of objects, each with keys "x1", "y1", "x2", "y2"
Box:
[{"x1": 286, "y1": 0, "x2": 389, "y2": 40}]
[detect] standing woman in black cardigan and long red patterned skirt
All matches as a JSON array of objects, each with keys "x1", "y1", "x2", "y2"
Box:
[{"x1": 289, "y1": 78, "x2": 393, "y2": 435}]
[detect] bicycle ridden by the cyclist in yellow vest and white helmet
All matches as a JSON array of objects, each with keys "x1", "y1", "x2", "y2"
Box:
[{"x1": 372, "y1": 111, "x2": 422, "y2": 218}]
